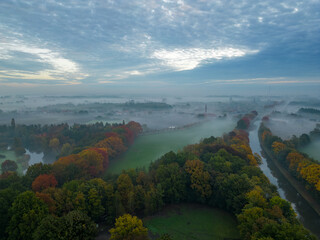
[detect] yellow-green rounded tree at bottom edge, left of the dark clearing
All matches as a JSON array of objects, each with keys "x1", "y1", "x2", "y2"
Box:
[{"x1": 109, "y1": 214, "x2": 148, "y2": 240}]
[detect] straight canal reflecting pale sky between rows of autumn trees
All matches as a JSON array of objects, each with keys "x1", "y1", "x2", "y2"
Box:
[{"x1": 249, "y1": 119, "x2": 320, "y2": 239}]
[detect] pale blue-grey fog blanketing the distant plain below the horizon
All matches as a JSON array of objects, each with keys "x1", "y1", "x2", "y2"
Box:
[{"x1": 0, "y1": 94, "x2": 320, "y2": 132}]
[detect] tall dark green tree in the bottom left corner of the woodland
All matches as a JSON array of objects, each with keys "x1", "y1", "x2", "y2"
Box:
[{"x1": 7, "y1": 191, "x2": 49, "y2": 240}]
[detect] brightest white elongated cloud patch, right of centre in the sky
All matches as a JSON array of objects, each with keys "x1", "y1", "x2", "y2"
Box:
[{"x1": 151, "y1": 47, "x2": 258, "y2": 71}]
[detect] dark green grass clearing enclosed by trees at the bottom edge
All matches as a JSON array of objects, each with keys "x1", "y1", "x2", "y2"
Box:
[{"x1": 143, "y1": 204, "x2": 240, "y2": 240}]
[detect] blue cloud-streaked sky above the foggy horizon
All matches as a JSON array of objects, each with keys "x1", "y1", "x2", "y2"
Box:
[{"x1": 0, "y1": 0, "x2": 320, "y2": 95}]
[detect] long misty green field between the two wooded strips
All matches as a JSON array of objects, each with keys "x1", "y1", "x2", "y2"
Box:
[{"x1": 107, "y1": 119, "x2": 235, "y2": 173}]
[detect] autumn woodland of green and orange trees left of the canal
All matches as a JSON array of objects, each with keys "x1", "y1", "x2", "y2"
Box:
[{"x1": 0, "y1": 115, "x2": 316, "y2": 240}]
